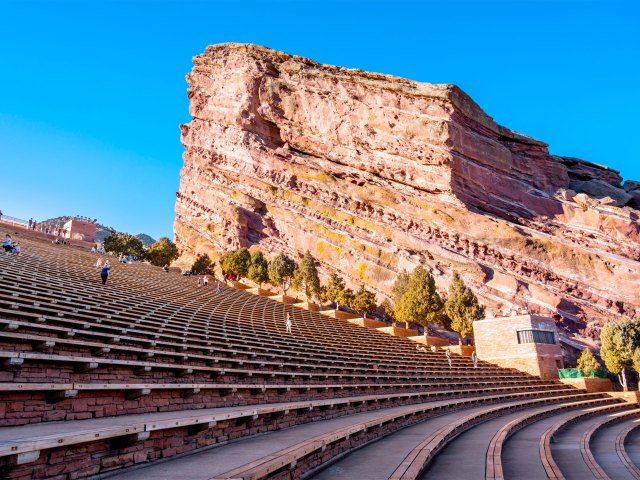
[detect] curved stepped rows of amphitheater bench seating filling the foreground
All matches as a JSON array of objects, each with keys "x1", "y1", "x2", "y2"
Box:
[{"x1": 0, "y1": 228, "x2": 637, "y2": 480}]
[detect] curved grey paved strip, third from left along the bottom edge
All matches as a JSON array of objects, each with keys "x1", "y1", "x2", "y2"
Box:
[{"x1": 420, "y1": 409, "x2": 538, "y2": 480}]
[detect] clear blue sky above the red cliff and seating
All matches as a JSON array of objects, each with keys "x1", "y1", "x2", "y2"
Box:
[{"x1": 0, "y1": 0, "x2": 640, "y2": 238}]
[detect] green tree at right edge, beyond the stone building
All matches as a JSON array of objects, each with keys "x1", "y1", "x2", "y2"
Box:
[{"x1": 600, "y1": 319, "x2": 640, "y2": 391}]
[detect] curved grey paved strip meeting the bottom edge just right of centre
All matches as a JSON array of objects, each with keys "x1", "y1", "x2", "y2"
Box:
[{"x1": 312, "y1": 405, "x2": 487, "y2": 480}]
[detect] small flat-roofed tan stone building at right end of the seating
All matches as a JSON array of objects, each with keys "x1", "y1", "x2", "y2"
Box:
[{"x1": 473, "y1": 315, "x2": 563, "y2": 379}]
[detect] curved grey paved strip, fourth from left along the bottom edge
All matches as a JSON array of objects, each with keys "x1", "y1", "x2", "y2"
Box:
[{"x1": 502, "y1": 410, "x2": 575, "y2": 480}]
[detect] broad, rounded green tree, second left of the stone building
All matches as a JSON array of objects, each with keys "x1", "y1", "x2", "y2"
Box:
[{"x1": 394, "y1": 266, "x2": 443, "y2": 338}]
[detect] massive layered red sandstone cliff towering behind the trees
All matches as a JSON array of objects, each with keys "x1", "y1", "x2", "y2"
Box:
[{"x1": 174, "y1": 44, "x2": 640, "y2": 342}]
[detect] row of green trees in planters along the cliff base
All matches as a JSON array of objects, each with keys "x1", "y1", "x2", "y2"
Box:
[{"x1": 192, "y1": 248, "x2": 484, "y2": 342}]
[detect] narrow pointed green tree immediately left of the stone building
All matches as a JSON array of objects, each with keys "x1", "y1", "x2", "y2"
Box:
[{"x1": 444, "y1": 272, "x2": 484, "y2": 345}]
